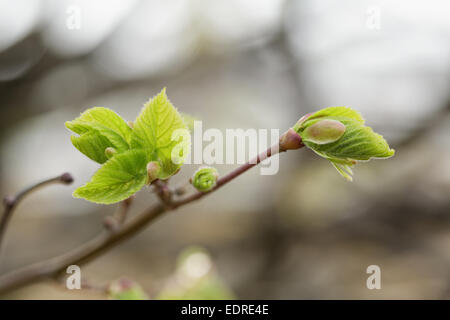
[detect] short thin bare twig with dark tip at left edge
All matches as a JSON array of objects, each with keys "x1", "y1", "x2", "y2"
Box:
[{"x1": 0, "y1": 172, "x2": 73, "y2": 252}]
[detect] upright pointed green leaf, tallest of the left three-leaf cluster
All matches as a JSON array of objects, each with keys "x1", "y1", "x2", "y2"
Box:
[{"x1": 131, "y1": 88, "x2": 190, "y2": 179}]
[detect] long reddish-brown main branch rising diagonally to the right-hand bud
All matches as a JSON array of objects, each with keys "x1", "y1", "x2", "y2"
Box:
[{"x1": 0, "y1": 145, "x2": 301, "y2": 294}]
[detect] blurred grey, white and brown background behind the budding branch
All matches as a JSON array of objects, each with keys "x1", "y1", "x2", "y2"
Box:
[{"x1": 0, "y1": 0, "x2": 450, "y2": 299}]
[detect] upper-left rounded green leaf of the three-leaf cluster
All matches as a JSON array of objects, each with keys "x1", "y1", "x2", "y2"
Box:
[{"x1": 66, "y1": 107, "x2": 131, "y2": 163}]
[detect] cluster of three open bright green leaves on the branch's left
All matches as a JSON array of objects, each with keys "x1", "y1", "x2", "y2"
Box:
[{"x1": 66, "y1": 89, "x2": 190, "y2": 204}]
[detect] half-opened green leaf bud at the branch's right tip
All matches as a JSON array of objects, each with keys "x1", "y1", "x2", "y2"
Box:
[{"x1": 293, "y1": 107, "x2": 395, "y2": 180}]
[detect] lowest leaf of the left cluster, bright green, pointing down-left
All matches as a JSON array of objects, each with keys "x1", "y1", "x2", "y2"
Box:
[{"x1": 73, "y1": 149, "x2": 148, "y2": 204}]
